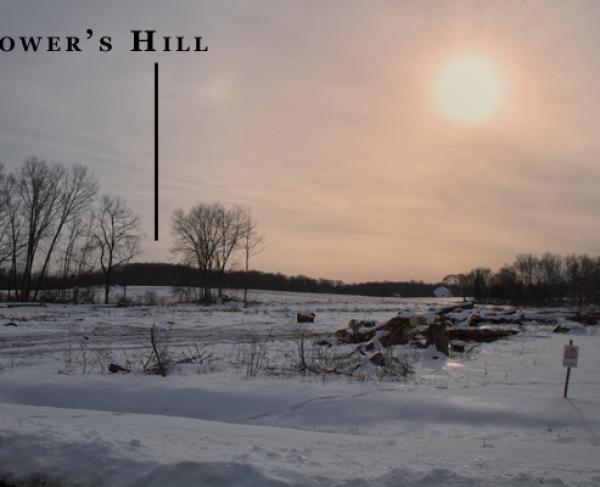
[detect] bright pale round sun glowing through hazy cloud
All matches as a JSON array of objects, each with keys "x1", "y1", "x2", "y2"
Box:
[{"x1": 435, "y1": 56, "x2": 503, "y2": 124}]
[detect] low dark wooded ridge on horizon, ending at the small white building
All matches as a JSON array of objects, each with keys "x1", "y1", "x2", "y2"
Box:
[{"x1": 0, "y1": 263, "x2": 439, "y2": 297}]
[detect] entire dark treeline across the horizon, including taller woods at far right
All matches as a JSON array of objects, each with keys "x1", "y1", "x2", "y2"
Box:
[{"x1": 0, "y1": 253, "x2": 600, "y2": 306}]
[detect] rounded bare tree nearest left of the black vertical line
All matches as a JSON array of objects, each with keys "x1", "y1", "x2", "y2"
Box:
[{"x1": 94, "y1": 195, "x2": 142, "y2": 303}]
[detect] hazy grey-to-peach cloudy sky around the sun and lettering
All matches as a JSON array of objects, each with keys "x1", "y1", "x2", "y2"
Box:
[{"x1": 0, "y1": 0, "x2": 600, "y2": 282}]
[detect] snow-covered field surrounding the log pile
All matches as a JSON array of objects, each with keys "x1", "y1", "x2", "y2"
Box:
[{"x1": 0, "y1": 288, "x2": 600, "y2": 487}]
